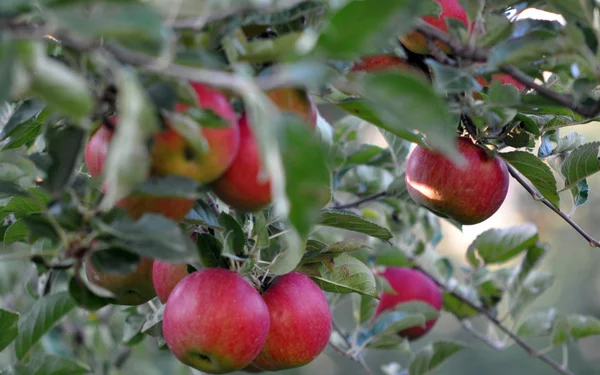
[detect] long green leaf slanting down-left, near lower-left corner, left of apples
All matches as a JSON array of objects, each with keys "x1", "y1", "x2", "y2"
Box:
[{"x1": 14, "y1": 292, "x2": 75, "y2": 360}]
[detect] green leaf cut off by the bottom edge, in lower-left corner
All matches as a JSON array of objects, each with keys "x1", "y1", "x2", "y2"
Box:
[{"x1": 14, "y1": 354, "x2": 92, "y2": 375}]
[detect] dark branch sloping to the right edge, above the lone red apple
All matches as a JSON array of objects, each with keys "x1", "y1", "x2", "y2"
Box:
[{"x1": 415, "y1": 21, "x2": 600, "y2": 117}]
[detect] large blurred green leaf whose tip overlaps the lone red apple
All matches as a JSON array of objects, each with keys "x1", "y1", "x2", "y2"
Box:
[{"x1": 360, "y1": 71, "x2": 465, "y2": 165}]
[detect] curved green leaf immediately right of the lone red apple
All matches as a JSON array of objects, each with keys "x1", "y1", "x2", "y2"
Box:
[{"x1": 499, "y1": 151, "x2": 560, "y2": 208}]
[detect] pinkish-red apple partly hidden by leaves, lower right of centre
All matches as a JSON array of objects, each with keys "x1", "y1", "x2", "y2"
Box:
[{"x1": 373, "y1": 267, "x2": 443, "y2": 340}]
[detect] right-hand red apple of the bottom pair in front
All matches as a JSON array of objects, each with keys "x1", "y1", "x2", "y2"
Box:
[{"x1": 253, "y1": 272, "x2": 332, "y2": 371}]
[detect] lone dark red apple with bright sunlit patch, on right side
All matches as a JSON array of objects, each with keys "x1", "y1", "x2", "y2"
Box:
[{"x1": 406, "y1": 137, "x2": 509, "y2": 225}]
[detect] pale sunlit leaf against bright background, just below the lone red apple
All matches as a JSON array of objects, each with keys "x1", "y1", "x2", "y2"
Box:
[{"x1": 467, "y1": 223, "x2": 538, "y2": 266}]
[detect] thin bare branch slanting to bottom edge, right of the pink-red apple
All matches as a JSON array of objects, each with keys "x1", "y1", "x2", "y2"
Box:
[{"x1": 413, "y1": 264, "x2": 574, "y2": 375}]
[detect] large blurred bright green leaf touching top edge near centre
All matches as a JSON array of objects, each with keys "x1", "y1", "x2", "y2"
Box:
[{"x1": 317, "y1": 0, "x2": 431, "y2": 59}]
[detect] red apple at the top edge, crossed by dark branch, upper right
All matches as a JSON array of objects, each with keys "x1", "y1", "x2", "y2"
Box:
[{"x1": 400, "y1": 0, "x2": 469, "y2": 55}]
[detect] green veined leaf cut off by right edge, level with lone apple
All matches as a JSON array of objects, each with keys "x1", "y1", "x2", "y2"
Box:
[{"x1": 561, "y1": 142, "x2": 600, "y2": 190}]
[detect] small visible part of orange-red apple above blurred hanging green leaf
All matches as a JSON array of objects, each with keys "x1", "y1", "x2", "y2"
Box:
[{"x1": 267, "y1": 87, "x2": 318, "y2": 127}]
